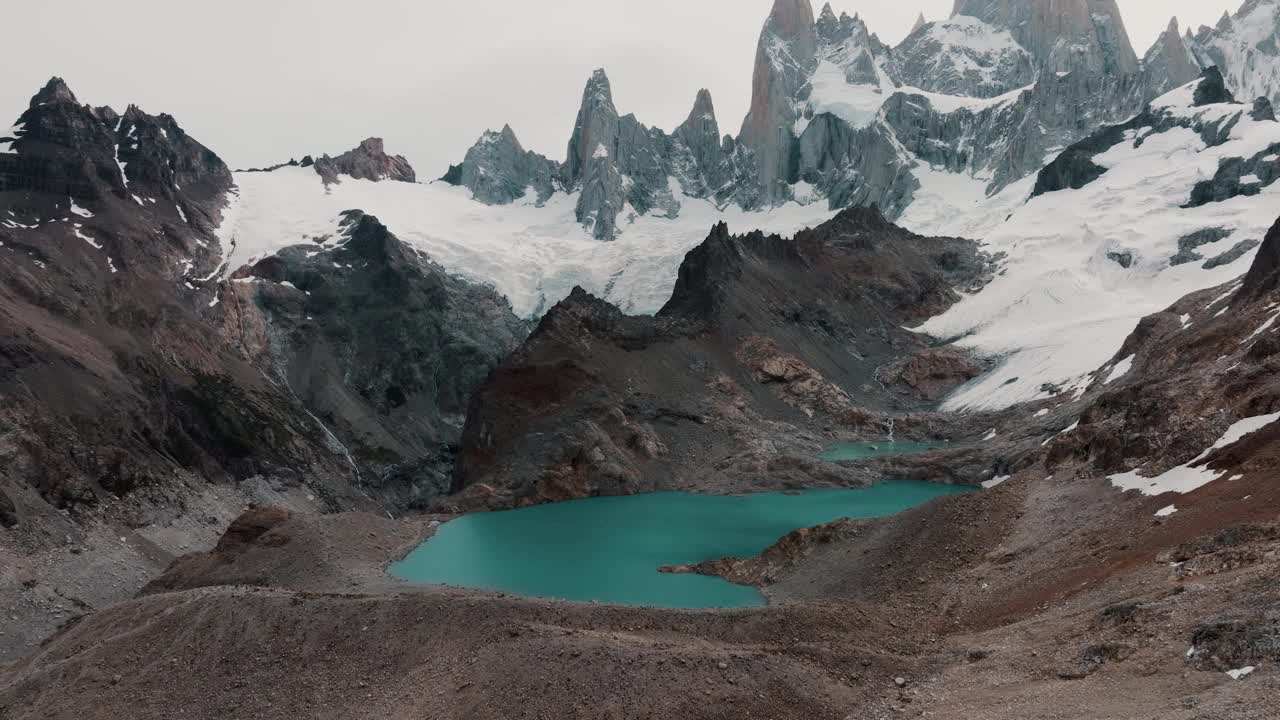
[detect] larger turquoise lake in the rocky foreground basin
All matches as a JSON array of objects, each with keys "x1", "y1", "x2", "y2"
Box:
[{"x1": 390, "y1": 479, "x2": 970, "y2": 607}]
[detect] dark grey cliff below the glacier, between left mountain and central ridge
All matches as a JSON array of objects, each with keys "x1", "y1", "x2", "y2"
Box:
[{"x1": 233, "y1": 211, "x2": 527, "y2": 507}]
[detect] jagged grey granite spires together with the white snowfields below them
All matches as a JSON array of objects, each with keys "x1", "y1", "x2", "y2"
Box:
[{"x1": 207, "y1": 0, "x2": 1280, "y2": 406}]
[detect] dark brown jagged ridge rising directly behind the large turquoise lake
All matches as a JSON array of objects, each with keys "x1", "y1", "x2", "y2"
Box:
[{"x1": 453, "y1": 210, "x2": 987, "y2": 507}]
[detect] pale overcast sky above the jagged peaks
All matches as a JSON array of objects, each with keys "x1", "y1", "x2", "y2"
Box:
[{"x1": 0, "y1": 0, "x2": 1243, "y2": 179}]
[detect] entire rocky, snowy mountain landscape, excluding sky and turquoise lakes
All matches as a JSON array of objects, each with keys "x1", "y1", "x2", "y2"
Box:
[{"x1": 0, "y1": 0, "x2": 1280, "y2": 720}]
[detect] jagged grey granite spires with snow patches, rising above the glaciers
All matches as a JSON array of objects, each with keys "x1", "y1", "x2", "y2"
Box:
[{"x1": 444, "y1": 0, "x2": 1276, "y2": 240}]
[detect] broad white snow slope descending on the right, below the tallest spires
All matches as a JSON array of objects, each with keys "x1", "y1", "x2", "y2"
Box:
[{"x1": 901, "y1": 75, "x2": 1280, "y2": 409}]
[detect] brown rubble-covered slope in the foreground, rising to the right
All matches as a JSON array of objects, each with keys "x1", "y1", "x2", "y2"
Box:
[{"x1": 0, "y1": 208, "x2": 1280, "y2": 720}]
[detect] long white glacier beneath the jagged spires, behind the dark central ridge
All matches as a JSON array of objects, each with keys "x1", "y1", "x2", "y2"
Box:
[{"x1": 219, "y1": 167, "x2": 832, "y2": 316}]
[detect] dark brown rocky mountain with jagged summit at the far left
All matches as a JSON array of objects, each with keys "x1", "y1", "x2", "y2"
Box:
[{"x1": 0, "y1": 79, "x2": 360, "y2": 510}]
